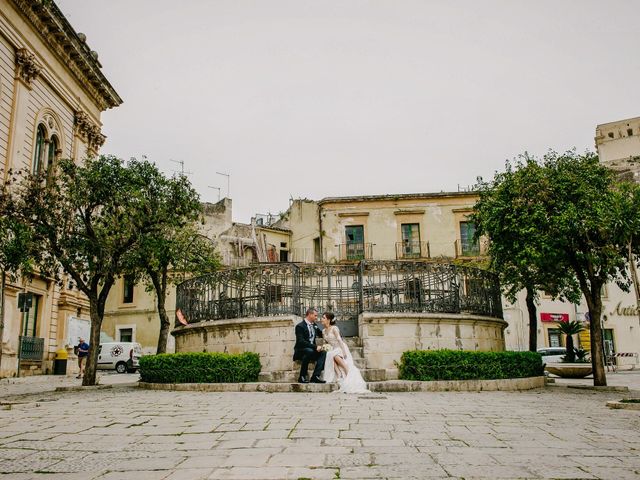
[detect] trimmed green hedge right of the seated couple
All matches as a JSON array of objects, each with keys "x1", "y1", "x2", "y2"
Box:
[{"x1": 399, "y1": 350, "x2": 544, "y2": 381}]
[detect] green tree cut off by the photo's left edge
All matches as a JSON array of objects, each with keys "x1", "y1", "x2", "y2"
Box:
[{"x1": 0, "y1": 176, "x2": 35, "y2": 372}]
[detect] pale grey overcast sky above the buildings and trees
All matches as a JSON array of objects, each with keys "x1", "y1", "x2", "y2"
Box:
[{"x1": 56, "y1": 0, "x2": 640, "y2": 222}]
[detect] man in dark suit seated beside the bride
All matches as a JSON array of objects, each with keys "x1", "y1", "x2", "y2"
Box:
[{"x1": 293, "y1": 308, "x2": 327, "y2": 383}]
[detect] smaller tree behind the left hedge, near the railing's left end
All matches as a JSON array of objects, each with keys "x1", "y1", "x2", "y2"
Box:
[{"x1": 129, "y1": 220, "x2": 220, "y2": 353}]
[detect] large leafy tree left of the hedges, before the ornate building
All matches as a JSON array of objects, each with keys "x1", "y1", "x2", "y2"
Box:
[{"x1": 19, "y1": 156, "x2": 196, "y2": 385}]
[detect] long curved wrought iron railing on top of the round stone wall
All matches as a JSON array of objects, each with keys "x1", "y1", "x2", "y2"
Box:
[{"x1": 176, "y1": 260, "x2": 502, "y2": 323}]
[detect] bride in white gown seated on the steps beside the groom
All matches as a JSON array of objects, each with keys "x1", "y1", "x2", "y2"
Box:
[{"x1": 320, "y1": 312, "x2": 369, "y2": 393}]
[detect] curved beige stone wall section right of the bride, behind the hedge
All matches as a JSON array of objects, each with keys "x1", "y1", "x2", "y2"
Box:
[{"x1": 358, "y1": 313, "x2": 507, "y2": 380}]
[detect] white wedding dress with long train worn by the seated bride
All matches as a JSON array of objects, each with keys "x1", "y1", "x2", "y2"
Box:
[{"x1": 322, "y1": 325, "x2": 369, "y2": 393}]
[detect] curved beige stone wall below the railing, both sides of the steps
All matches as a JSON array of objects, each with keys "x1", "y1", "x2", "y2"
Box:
[{"x1": 172, "y1": 313, "x2": 507, "y2": 381}]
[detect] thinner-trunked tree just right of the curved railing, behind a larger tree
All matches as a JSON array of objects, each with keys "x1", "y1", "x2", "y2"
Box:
[{"x1": 471, "y1": 157, "x2": 579, "y2": 352}]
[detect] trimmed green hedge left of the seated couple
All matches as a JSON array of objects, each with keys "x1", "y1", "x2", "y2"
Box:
[{"x1": 140, "y1": 352, "x2": 261, "y2": 383}]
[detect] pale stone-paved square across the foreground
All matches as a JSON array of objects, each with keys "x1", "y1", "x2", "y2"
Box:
[{"x1": 0, "y1": 386, "x2": 640, "y2": 480}]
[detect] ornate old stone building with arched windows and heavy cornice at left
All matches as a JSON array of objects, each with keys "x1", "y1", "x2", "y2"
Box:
[{"x1": 0, "y1": 0, "x2": 122, "y2": 376}]
